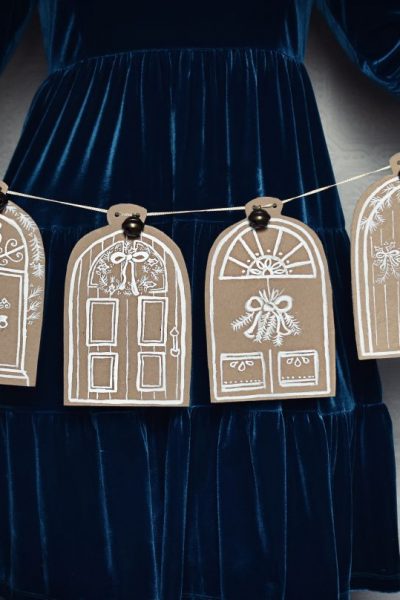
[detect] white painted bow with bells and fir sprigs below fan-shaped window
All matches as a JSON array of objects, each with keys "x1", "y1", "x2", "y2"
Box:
[{"x1": 231, "y1": 289, "x2": 301, "y2": 346}]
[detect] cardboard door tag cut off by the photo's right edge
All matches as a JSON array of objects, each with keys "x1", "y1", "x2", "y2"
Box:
[{"x1": 351, "y1": 153, "x2": 400, "y2": 359}]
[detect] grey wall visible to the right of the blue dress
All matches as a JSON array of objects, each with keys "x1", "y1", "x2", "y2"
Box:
[{"x1": 306, "y1": 18, "x2": 400, "y2": 600}]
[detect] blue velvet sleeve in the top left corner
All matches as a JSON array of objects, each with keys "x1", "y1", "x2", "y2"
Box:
[{"x1": 0, "y1": 0, "x2": 37, "y2": 74}]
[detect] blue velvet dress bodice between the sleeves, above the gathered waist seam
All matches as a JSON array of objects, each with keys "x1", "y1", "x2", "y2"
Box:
[{"x1": 39, "y1": 0, "x2": 313, "y2": 72}]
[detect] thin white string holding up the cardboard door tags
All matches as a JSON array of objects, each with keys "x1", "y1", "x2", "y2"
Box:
[{"x1": 2, "y1": 165, "x2": 391, "y2": 217}]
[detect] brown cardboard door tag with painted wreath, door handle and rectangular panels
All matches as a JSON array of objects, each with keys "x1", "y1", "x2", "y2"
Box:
[{"x1": 64, "y1": 204, "x2": 191, "y2": 407}]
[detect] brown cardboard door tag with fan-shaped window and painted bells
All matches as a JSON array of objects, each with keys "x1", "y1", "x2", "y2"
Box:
[{"x1": 206, "y1": 198, "x2": 335, "y2": 402}]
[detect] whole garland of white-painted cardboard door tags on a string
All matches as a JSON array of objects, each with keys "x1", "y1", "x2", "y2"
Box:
[{"x1": 0, "y1": 153, "x2": 400, "y2": 406}]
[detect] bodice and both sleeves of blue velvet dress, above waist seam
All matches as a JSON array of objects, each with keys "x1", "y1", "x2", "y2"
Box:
[{"x1": 0, "y1": 0, "x2": 400, "y2": 95}]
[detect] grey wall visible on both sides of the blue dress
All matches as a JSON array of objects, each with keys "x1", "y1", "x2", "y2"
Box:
[{"x1": 0, "y1": 5, "x2": 400, "y2": 600}]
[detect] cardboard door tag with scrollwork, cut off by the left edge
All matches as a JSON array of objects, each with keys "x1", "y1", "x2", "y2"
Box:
[{"x1": 0, "y1": 181, "x2": 45, "y2": 387}]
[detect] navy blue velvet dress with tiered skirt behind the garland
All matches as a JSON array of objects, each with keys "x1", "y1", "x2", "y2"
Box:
[{"x1": 0, "y1": 0, "x2": 400, "y2": 600}]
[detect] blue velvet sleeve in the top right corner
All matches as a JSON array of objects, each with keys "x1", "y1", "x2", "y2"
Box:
[{"x1": 316, "y1": 0, "x2": 400, "y2": 95}]
